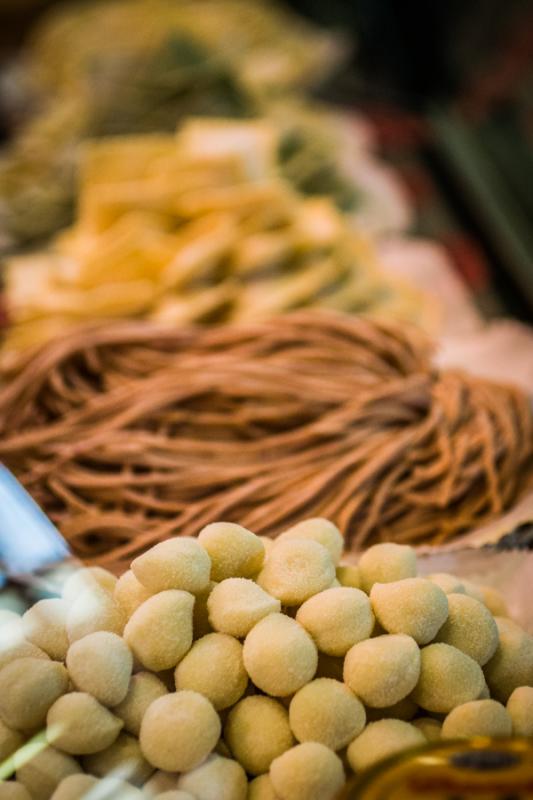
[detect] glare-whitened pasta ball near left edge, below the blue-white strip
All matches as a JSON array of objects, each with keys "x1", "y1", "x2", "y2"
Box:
[{"x1": 22, "y1": 597, "x2": 68, "y2": 661}]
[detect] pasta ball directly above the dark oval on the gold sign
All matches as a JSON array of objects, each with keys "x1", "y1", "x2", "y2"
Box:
[{"x1": 441, "y1": 700, "x2": 513, "y2": 739}]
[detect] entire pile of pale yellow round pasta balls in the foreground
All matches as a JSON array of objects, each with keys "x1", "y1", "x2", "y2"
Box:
[{"x1": 0, "y1": 519, "x2": 533, "y2": 800}]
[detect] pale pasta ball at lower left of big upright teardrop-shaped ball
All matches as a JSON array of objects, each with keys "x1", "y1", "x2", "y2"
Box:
[{"x1": 67, "y1": 631, "x2": 133, "y2": 706}]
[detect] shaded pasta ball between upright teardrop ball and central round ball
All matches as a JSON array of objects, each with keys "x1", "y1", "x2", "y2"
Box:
[{"x1": 176, "y1": 633, "x2": 248, "y2": 710}]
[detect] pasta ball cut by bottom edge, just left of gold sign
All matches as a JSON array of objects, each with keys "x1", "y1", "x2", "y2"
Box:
[{"x1": 270, "y1": 742, "x2": 344, "y2": 800}]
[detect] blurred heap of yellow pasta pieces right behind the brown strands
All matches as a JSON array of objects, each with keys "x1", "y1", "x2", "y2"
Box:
[{"x1": 4, "y1": 119, "x2": 430, "y2": 366}]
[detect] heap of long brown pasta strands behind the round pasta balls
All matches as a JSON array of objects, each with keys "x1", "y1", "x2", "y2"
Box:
[{"x1": 0, "y1": 311, "x2": 533, "y2": 571}]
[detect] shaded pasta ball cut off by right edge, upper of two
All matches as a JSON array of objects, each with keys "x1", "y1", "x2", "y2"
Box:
[{"x1": 485, "y1": 618, "x2": 533, "y2": 703}]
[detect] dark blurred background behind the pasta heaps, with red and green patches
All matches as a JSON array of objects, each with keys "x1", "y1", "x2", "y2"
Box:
[{"x1": 0, "y1": 0, "x2": 533, "y2": 321}]
